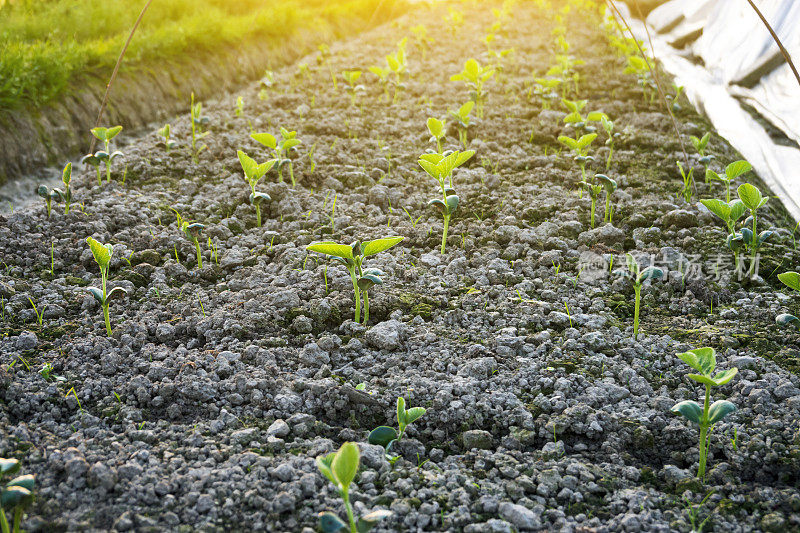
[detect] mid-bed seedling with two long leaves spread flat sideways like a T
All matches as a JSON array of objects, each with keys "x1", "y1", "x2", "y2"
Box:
[{"x1": 306, "y1": 237, "x2": 403, "y2": 325}]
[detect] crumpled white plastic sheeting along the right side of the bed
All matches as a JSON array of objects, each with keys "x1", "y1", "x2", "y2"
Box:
[{"x1": 617, "y1": 0, "x2": 800, "y2": 220}]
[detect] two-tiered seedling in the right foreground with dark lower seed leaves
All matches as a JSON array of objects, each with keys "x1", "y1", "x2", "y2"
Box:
[{"x1": 670, "y1": 346, "x2": 739, "y2": 480}]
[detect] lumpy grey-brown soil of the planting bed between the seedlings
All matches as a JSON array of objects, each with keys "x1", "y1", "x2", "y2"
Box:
[{"x1": 0, "y1": 3, "x2": 800, "y2": 533}]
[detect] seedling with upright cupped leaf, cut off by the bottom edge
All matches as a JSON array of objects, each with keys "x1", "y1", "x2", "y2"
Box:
[{"x1": 316, "y1": 442, "x2": 392, "y2": 533}]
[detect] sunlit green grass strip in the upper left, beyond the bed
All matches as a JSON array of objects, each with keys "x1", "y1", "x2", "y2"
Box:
[{"x1": 0, "y1": 0, "x2": 403, "y2": 109}]
